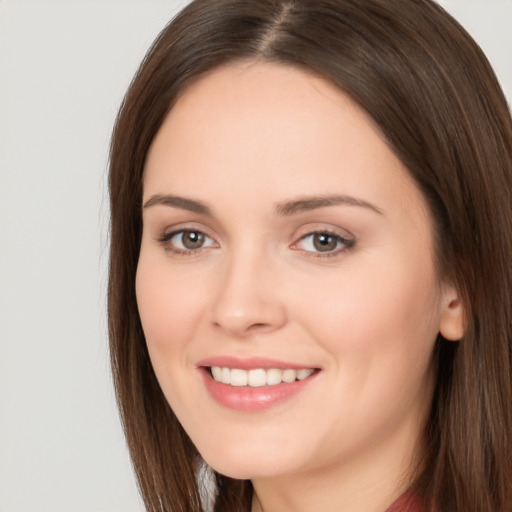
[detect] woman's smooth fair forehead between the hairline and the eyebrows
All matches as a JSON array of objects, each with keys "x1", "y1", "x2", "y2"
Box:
[{"x1": 144, "y1": 62, "x2": 420, "y2": 214}]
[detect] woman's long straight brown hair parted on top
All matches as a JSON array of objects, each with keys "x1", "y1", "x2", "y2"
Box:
[{"x1": 108, "y1": 0, "x2": 512, "y2": 512}]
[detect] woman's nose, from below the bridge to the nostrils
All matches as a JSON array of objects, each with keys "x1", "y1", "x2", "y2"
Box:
[{"x1": 212, "y1": 249, "x2": 287, "y2": 338}]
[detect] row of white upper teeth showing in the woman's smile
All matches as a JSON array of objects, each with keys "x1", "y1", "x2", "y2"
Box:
[{"x1": 211, "y1": 366, "x2": 314, "y2": 388}]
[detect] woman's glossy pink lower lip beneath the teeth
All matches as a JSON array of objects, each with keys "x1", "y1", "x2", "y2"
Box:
[{"x1": 201, "y1": 368, "x2": 317, "y2": 412}]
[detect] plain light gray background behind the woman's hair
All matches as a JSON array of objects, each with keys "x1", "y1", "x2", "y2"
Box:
[{"x1": 0, "y1": 0, "x2": 512, "y2": 512}]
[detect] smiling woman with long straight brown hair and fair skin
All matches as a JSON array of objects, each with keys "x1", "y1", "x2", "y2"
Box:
[{"x1": 109, "y1": 0, "x2": 512, "y2": 512}]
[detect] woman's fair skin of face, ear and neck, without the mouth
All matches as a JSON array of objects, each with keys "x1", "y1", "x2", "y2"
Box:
[{"x1": 136, "y1": 62, "x2": 462, "y2": 512}]
